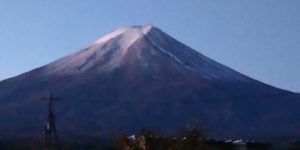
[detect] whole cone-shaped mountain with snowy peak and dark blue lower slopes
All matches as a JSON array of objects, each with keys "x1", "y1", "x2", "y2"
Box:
[{"x1": 0, "y1": 26, "x2": 300, "y2": 138}]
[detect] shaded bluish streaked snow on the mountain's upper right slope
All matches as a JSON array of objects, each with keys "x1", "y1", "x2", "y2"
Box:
[{"x1": 146, "y1": 28, "x2": 249, "y2": 81}]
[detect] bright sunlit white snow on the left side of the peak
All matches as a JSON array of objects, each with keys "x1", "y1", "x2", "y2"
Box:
[{"x1": 46, "y1": 26, "x2": 152, "y2": 74}]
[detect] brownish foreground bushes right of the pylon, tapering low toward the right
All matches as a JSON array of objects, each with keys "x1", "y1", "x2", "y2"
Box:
[{"x1": 118, "y1": 130, "x2": 271, "y2": 150}]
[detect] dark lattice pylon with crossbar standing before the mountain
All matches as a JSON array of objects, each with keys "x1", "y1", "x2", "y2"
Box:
[{"x1": 43, "y1": 92, "x2": 61, "y2": 150}]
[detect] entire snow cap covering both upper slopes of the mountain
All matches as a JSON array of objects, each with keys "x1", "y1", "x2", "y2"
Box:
[{"x1": 45, "y1": 25, "x2": 247, "y2": 80}]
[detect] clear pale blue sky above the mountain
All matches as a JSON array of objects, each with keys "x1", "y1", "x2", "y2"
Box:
[{"x1": 0, "y1": 0, "x2": 300, "y2": 92}]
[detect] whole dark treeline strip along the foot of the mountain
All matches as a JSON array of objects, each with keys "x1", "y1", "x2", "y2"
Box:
[{"x1": 0, "y1": 130, "x2": 271, "y2": 150}]
